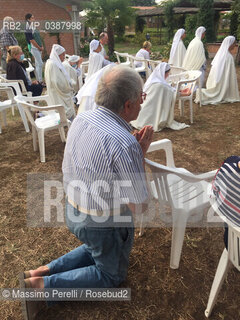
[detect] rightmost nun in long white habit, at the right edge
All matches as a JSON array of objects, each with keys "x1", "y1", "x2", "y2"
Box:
[{"x1": 195, "y1": 36, "x2": 239, "y2": 105}]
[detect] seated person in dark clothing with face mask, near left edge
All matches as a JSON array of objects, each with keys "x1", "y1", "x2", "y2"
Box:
[{"x1": 7, "y1": 46, "x2": 43, "y2": 97}]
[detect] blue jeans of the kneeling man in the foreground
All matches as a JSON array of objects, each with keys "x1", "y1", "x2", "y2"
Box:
[{"x1": 43, "y1": 203, "x2": 134, "y2": 288}]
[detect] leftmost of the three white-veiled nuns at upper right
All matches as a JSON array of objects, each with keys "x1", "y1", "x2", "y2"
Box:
[{"x1": 168, "y1": 29, "x2": 186, "y2": 67}]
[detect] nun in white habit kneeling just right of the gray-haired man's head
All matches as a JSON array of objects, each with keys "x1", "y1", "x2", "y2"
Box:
[{"x1": 131, "y1": 62, "x2": 189, "y2": 132}]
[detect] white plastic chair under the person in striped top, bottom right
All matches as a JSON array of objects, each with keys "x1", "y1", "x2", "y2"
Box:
[{"x1": 205, "y1": 200, "x2": 240, "y2": 318}]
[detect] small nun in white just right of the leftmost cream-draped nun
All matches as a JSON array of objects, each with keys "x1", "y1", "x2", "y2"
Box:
[{"x1": 63, "y1": 55, "x2": 83, "y2": 93}]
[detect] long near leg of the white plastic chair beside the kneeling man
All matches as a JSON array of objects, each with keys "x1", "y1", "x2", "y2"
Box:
[{"x1": 170, "y1": 212, "x2": 187, "y2": 269}]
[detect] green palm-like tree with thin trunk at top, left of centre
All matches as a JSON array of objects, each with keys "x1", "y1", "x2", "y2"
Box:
[{"x1": 86, "y1": 0, "x2": 135, "y2": 55}]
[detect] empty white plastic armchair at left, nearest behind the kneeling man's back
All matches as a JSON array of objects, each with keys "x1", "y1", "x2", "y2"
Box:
[{"x1": 15, "y1": 96, "x2": 71, "y2": 162}]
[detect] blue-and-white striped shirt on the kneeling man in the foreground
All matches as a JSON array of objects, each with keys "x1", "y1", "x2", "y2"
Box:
[{"x1": 62, "y1": 107, "x2": 148, "y2": 211}]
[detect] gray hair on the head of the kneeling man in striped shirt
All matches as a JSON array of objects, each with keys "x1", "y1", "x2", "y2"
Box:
[{"x1": 95, "y1": 66, "x2": 143, "y2": 113}]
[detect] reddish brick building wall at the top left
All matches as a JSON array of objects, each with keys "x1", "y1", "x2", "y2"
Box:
[{"x1": 0, "y1": 0, "x2": 74, "y2": 55}]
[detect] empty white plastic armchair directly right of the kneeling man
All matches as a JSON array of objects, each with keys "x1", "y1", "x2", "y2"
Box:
[{"x1": 140, "y1": 139, "x2": 216, "y2": 269}]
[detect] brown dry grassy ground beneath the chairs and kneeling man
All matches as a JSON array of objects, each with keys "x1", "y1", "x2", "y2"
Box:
[{"x1": 0, "y1": 62, "x2": 240, "y2": 320}]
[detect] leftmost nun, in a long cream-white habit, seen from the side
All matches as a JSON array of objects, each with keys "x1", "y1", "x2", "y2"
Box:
[{"x1": 45, "y1": 44, "x2": 75, "y2": 121}]
